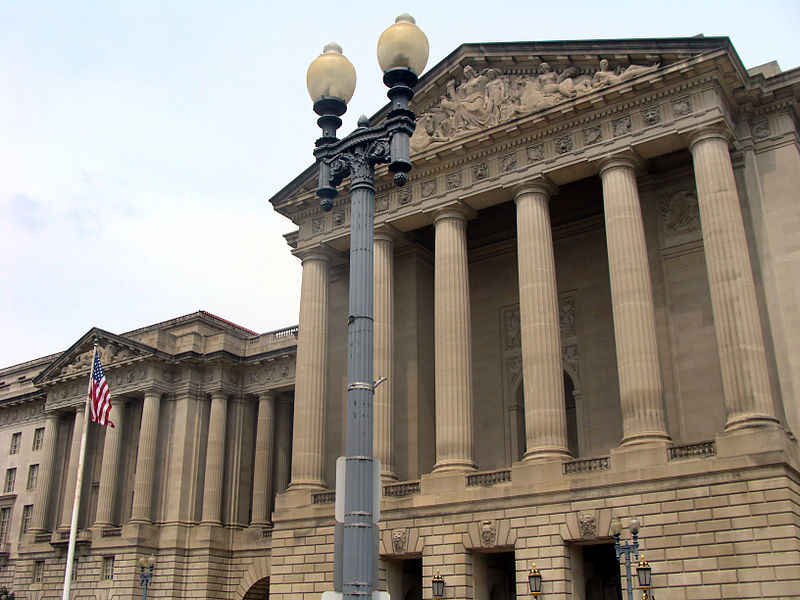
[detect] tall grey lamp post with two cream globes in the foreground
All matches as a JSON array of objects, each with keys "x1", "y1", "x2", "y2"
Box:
[{"x1": 306, "y1": 14, "x2": 428, "y2": 600}]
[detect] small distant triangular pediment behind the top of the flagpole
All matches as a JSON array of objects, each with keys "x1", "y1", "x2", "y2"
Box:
[{"x1": 34, "y1": 327, "x2": 156, "y2": 386}]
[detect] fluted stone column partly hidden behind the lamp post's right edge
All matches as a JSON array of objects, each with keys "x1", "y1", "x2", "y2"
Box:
[{"x1": 373, "y1": 225, "x2": 397, "y2": 481}]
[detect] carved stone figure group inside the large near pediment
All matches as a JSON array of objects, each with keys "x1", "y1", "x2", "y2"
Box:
[{"x1": 411, "y1": 59, "x2": 660, "y2": 151}]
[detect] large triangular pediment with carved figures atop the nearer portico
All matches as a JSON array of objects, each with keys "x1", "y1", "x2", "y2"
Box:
[{"x1": 270, "y1": 37, "x2": 748, "y2": 216}]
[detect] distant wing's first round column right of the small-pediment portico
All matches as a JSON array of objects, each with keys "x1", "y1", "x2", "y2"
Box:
[{"x1": 201, "y1": 392, "x2": 228, "y2": 525}]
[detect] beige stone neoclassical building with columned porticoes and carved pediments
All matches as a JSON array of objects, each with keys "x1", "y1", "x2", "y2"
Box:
[{"x1": 0, "y1": 37, "x2": 800, "y2": 600}]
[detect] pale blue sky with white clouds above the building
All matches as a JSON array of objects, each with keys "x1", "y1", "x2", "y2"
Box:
[{"x1": 0, "y1": 0, "x2": 800, "y2": 367}]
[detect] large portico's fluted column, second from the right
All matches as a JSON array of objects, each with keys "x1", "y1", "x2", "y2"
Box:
[{"x1": 600, "y1": 155, "x2": 669, "y2": 445}]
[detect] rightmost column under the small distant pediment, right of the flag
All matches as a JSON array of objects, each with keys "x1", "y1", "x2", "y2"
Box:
[{"x1": 131, "y1": 390, "x2": 161, "y2": 523}]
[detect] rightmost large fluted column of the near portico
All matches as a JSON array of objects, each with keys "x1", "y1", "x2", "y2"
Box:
[{"x1": 689, "y1": 129, "x2": 777, "y2": 429}]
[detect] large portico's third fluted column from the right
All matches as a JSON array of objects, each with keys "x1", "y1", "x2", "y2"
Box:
[{"x1": 514, "y1": 181, "x2": 569, "y2": 460}]
